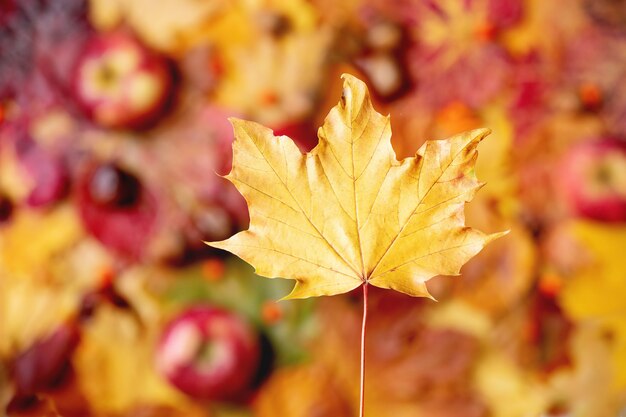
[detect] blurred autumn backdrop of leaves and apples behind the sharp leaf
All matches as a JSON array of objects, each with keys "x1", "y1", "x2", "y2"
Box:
[{"x1": 0, "y1": 0, "x2": 626, "y2": 417}]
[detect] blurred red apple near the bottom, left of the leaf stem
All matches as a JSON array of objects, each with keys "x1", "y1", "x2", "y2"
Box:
[{"x1": 156, "y1": 306, "x2": 260, "y2": 401}]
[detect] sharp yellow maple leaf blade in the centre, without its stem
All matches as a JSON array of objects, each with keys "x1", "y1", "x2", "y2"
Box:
[{"x1": 207, "y1": 75, "x2": 503, "y2": 298}]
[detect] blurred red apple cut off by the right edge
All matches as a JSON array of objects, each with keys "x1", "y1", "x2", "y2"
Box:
[{"x1": 559, "y1": 138, "x2": 626, "y2": 222}]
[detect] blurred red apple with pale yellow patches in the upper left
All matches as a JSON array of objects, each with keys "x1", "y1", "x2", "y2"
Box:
[{"x1": 73, "y1": 32, "x2": 173, "y2": 128}]
